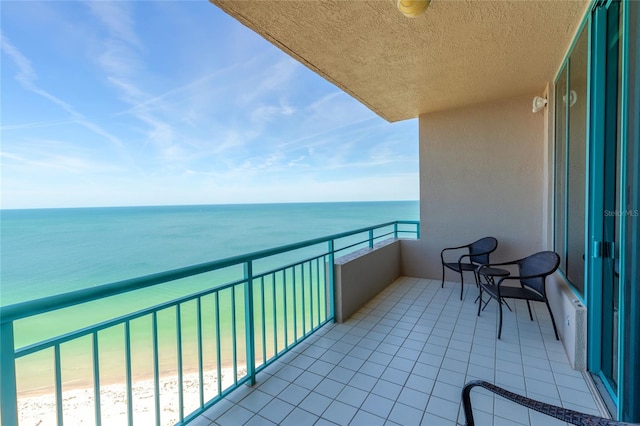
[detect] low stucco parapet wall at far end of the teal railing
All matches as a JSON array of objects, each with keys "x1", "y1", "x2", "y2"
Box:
[{"x1": 334, "y1": 239, "x2": 400, "y2": 322}]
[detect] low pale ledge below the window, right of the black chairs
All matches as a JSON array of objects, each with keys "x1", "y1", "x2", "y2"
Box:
[{"x1": 547, "y1": 273, "x2": 587, "y2": 371}]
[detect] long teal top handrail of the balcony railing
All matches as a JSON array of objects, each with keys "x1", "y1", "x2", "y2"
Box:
[{"x1": 0, "y1": 220, "x2": 419, "y2": 324}]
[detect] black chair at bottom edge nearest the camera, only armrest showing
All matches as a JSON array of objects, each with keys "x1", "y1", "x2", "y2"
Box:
[{"x1": 462, "y1": 380, "x2": 632, "y2": 426}]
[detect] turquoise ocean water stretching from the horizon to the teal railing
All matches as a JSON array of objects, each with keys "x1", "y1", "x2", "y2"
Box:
[{"x1": 0, "y1": 201, "x2": 419, "y2": 391}]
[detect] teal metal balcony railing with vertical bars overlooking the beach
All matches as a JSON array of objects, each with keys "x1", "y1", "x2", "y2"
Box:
[{"x1": 0, "y1": 221, "x2": 420, "y2": 426}]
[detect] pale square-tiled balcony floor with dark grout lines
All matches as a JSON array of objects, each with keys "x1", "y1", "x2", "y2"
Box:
[{"x1": 191, "y1": 277, "x2": 601, "y2": 426}]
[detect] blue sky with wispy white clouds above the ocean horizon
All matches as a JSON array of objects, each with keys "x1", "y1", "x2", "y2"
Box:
[{"x1": 0, "y1": 0, "x2": 418, "y2": 208}]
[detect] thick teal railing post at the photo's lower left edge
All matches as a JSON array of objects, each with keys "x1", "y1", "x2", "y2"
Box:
[{"x1": 0, "y1": 321, "x2": 18, "y2": 425}]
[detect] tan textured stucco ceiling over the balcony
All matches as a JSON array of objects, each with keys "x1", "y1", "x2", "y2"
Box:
[{"x1": 211, "y1": 0, "x2": 589, "y2": 121}]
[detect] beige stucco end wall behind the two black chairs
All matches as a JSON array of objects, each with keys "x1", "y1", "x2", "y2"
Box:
[{"x1": 402, "y1": 93, "x2": 548, "y2": 280}]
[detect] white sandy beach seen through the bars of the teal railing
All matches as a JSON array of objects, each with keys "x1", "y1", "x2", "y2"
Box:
[{"x1": 18, "y1": 366, "x2": 246, "y2": 426}]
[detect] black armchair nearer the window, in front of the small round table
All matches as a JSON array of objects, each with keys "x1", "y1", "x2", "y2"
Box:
[{"x1": 476, "y1": 251, "x2": 560, "y2": 340}]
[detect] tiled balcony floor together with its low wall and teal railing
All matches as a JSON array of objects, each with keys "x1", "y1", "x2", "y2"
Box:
[{"x1": 1, "y1": 221, "x2": 602, "y2": 425}]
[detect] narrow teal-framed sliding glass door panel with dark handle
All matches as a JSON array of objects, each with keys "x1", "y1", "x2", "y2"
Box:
[{"x1": 589, "y1": 1, "x2": 622, "y2": 401}]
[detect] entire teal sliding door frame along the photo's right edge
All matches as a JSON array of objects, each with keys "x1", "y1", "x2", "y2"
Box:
[{"x1": 587, "y1": 0, "x2": 640, "y2": 422}]
